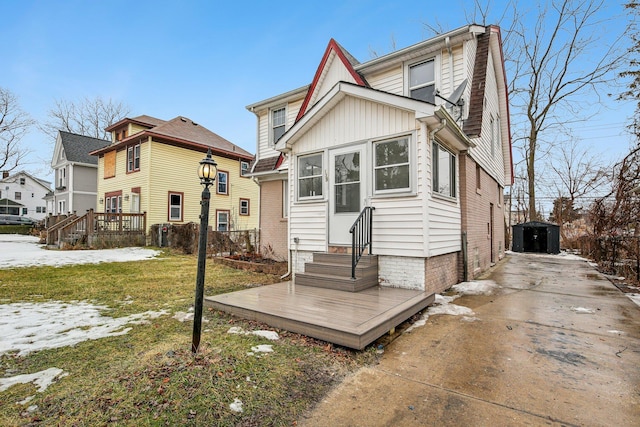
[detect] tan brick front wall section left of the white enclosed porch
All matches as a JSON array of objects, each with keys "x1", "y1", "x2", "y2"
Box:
[{"x1": 260, "y1": 181, "x2": 288, "y2": 261}]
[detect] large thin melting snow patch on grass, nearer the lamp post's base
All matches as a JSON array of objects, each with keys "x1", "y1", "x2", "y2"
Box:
[{"x1": 0, "y1": 301, "x2": 167, "y2": 356}]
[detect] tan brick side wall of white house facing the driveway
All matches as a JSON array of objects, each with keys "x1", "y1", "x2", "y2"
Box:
[{"x1": 459, "y1": 154, "x2": 505, "y2": 280}]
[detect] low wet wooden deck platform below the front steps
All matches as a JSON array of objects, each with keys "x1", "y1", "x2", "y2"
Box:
[{"x1": 205, "y1": 282, "x2": 435, "y2": 350}]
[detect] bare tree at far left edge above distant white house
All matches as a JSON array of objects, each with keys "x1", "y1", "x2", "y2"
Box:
[{"x1": 0, "y1": 87, "x2": 34, "y2": 172}]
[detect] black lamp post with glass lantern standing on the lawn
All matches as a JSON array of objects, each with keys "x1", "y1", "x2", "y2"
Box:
[{"x1": 191, "y1": 148, "x2": 218, "y2": 353}]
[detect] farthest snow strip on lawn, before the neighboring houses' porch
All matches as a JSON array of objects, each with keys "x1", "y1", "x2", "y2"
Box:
[{"x1": 0, "y1": 234, "x2": 160, "y2": 269}]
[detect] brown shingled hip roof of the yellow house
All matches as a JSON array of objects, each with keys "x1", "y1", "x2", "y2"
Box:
[{"x1": 91, "y1": 116, "x2": 253, "y2": 160}]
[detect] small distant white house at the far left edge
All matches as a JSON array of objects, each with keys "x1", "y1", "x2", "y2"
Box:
[{"x1": 0, "y1": 171, "x2": 51, "y2": 220}]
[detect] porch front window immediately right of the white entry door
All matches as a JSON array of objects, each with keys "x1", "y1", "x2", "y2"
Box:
[{"x1": 373, "y1": 138, "x2": 411, "y2": 193}]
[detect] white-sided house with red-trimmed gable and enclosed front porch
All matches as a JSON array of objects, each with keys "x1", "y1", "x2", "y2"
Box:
[{"x1": 247, "y1": 25, "x2": 513, "y2": 293}]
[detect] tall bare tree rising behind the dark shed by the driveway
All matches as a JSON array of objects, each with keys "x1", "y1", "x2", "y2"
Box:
[{"x1": 506, "y1": 0, "x2": 623, "y2": 219}]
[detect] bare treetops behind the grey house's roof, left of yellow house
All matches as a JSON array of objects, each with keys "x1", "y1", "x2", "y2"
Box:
[{"x1": 40, "y1": 96, "x2": 129, "y2": 141}]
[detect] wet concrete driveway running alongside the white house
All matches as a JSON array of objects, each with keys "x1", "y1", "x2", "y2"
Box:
[{"x1": 299, "y1": 254, "x2": 640, "y2": 426}]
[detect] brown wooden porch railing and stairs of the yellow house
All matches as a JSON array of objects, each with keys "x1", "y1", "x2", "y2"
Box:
[{"x1": 47, "y1": 209, "x2": 147, "y2": 247}]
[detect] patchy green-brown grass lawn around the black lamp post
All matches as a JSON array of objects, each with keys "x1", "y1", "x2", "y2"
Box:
[{"x1": 0, "y1": 251, "x2": 376, "y2": 426}]
